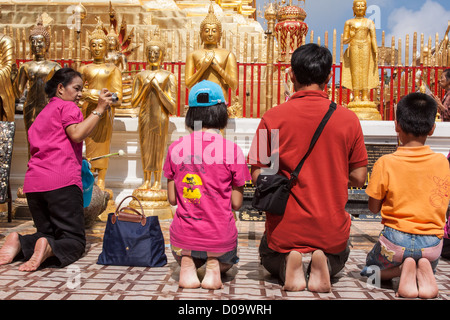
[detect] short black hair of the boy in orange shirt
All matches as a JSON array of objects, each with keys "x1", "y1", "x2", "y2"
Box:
[{"x1": 396, "y1": 92, "x2": 437, "y2": 137}]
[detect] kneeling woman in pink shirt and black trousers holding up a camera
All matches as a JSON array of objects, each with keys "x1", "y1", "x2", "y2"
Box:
[{"x1": 0, "y1": 68, "x2": 112, "y2": 271}]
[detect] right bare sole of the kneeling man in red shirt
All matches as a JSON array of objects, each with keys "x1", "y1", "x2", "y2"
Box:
[{"x1": 308, "y1": 250, "x2": 331, "y2": 292}]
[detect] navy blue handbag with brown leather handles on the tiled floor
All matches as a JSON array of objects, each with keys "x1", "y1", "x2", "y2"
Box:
[{"x1": 97, "y1": 196, "x2": 167, "y2": 267}]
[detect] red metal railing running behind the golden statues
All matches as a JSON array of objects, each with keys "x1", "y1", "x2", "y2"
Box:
[{"x1": 17, "y1": 59, "x2": 446, "y2": 120}]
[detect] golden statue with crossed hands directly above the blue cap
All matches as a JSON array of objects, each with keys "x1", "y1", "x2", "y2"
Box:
[{"x1": 185, "y1": 4, "x2": 238, "y2": 97}]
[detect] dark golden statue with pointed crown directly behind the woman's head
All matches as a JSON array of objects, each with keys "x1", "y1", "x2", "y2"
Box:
[{"x1": 13, "y1": 18, "x2": 61, "y2": 158}]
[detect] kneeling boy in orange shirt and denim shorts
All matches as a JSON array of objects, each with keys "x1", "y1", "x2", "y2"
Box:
[{"x1": 361, "y1": 93, "x2": 450, "y2": 299}]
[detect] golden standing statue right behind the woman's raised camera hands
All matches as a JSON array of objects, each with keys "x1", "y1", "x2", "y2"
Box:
[{"x1": 79, "y1": 19, "x2": 122, "y2": 192}]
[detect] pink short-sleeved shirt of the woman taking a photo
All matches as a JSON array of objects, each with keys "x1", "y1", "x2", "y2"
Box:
[{"x1": 23, "y1": 97, "x2": 83, "y2": 193}]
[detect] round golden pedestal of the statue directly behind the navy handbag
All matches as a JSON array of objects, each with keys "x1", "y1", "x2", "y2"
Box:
[{"x1": 128, "y1": 189, "x2": 174, "y2": 220}]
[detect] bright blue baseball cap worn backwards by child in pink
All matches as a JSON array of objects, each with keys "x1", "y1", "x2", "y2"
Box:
[{"x1": 189, "y1": 80, "x2": 226, "y2": 107}]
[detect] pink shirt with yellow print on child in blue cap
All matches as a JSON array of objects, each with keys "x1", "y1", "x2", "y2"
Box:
[{"x1": 164, "y1": 131, "x2": 251, "y2": 252}]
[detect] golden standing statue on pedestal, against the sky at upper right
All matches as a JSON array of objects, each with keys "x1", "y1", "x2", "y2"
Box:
[{"x1": 342, "y1": 0, "x2": 381, "y2": 120}]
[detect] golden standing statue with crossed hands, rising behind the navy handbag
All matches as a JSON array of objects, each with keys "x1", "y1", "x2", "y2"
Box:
[{"x1": 130, "y1": 36, "x2": 177, "y2": 219}]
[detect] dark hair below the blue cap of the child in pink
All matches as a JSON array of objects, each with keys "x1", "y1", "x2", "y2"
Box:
[{"x1": 185, "y1": 103, "x2": 228, "y2": 130}]
